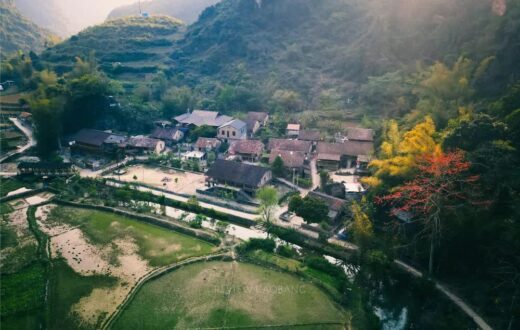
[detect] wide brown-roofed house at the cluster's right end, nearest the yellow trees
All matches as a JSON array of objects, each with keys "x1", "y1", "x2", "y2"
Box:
[{"x1": 316, "y1": 141, "x2": 374, "y2": 171}]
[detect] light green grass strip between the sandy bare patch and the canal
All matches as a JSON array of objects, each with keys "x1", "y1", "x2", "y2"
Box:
[{"x1": 45, "y1": 207, "x2": 215, "y2": 266}]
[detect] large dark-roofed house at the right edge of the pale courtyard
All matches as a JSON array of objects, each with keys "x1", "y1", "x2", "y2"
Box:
[{"x1": 206, "y1": 159, "x2": 272, "y2": 194}]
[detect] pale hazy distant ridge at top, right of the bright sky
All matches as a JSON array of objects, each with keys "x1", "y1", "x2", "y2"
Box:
[{"x1": 108, "y1": 0, "x2": 220, "y2": 24}]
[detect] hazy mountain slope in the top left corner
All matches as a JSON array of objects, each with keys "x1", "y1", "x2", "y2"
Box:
[{"x1": 0, "y1": 0, "x2": 52, "y2": 56}]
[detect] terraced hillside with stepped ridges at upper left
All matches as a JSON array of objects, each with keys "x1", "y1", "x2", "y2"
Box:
[{"x1": 42, "y1": 16, "x2": 183, "y2": 78}]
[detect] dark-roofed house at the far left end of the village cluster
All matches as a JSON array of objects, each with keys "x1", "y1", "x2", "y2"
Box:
[{"x1": 70, "y1": 129, "x2": 127, "y2": 154}]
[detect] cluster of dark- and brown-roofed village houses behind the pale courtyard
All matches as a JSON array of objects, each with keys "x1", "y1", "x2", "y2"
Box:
[{"x1": 71, "y1": 110, "x2": 373, "y2": 191}]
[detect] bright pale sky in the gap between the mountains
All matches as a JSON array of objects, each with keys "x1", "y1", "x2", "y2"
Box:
[{"x1": 56, "y1": 0, "x2": 137, "y2": 32}]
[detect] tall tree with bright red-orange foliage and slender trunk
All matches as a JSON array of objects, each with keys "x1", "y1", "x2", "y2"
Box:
[{"x1": 377, "y1": 151, "x2": 483, "y2": 274}]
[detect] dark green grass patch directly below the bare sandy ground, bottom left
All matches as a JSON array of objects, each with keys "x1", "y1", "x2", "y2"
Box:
[{"x1": 47, "y1": 259, "x2": 117, "y2": 329}]
